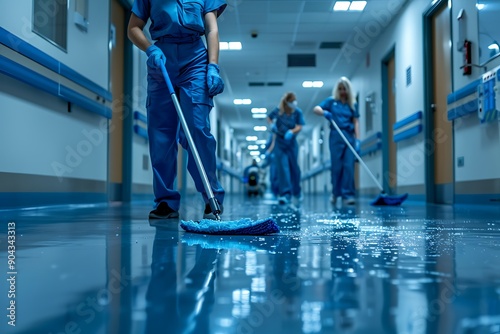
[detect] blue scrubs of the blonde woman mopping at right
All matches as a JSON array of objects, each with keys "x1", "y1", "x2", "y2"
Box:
[{"x1": 319, "y1": 97, "x2": 359, "y2": 199}]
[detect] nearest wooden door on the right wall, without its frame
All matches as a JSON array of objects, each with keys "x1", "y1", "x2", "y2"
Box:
[{"x1": 429, "y1": 2, "x2": 453, "y2": 204}]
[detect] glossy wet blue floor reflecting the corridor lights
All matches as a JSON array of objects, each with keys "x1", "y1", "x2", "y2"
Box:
[{"x1": 0, "y1": 195, "x2": 500, "y2": 334}]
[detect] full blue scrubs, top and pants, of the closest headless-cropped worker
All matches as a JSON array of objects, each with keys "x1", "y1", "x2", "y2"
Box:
[{"x1": 132, "y1": 0, "x2": 226, "y2": 210}]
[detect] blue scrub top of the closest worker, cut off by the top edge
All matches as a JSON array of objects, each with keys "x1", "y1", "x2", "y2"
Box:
[{"x1": 132, "y1": 0, "x2": 227, "y2": 40}]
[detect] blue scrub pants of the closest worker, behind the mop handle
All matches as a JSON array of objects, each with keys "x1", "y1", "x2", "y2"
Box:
[{"x1": 146, "y1": 37, "x2": 224, "y2": 210}]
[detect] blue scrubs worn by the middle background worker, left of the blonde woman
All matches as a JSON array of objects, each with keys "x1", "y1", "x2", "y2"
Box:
[{"x1": 267, "y1": 108, "x2": 305, "y2": 199}]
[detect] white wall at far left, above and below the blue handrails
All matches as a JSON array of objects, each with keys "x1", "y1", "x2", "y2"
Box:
[{"x1": 0, "y1": 1, "x2": 109, "y2": 181}]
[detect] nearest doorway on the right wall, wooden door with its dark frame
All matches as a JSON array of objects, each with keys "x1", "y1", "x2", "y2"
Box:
[{"x1": 424, "y1": 0, "x2": 454, "y2": 204}]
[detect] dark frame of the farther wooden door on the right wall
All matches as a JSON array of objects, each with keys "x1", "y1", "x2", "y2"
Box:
[{"x1": 381, "y1": 45, "x2": 397, "y2": 194}]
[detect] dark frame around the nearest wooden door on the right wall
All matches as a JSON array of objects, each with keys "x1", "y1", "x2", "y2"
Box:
[{"x1": 423, "y1": 0, "x2": 455, "y2": 203}]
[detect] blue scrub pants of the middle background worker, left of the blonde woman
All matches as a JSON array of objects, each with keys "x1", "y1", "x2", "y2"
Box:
[{"x1": 274, "y1": 138, "x2": 301, "y2": 197}]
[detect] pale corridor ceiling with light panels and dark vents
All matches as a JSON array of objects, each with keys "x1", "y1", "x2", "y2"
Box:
[{"x1": 215, "y1": 0, "x2": 411, "y2": 145}]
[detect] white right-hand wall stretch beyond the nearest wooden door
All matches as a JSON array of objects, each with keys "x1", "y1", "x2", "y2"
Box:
[{"x1": 352, "y1": 0, "x2": 430, "y2": 188}]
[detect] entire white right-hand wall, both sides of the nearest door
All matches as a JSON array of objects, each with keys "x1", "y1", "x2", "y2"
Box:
[{"x1": 346, "y1": 0, "x2": 500, "y2": 192}]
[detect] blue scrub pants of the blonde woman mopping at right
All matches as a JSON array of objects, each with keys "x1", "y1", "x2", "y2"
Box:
[{"x1": 329, "y1": 130, "x2": 355, "y2": 199}]
